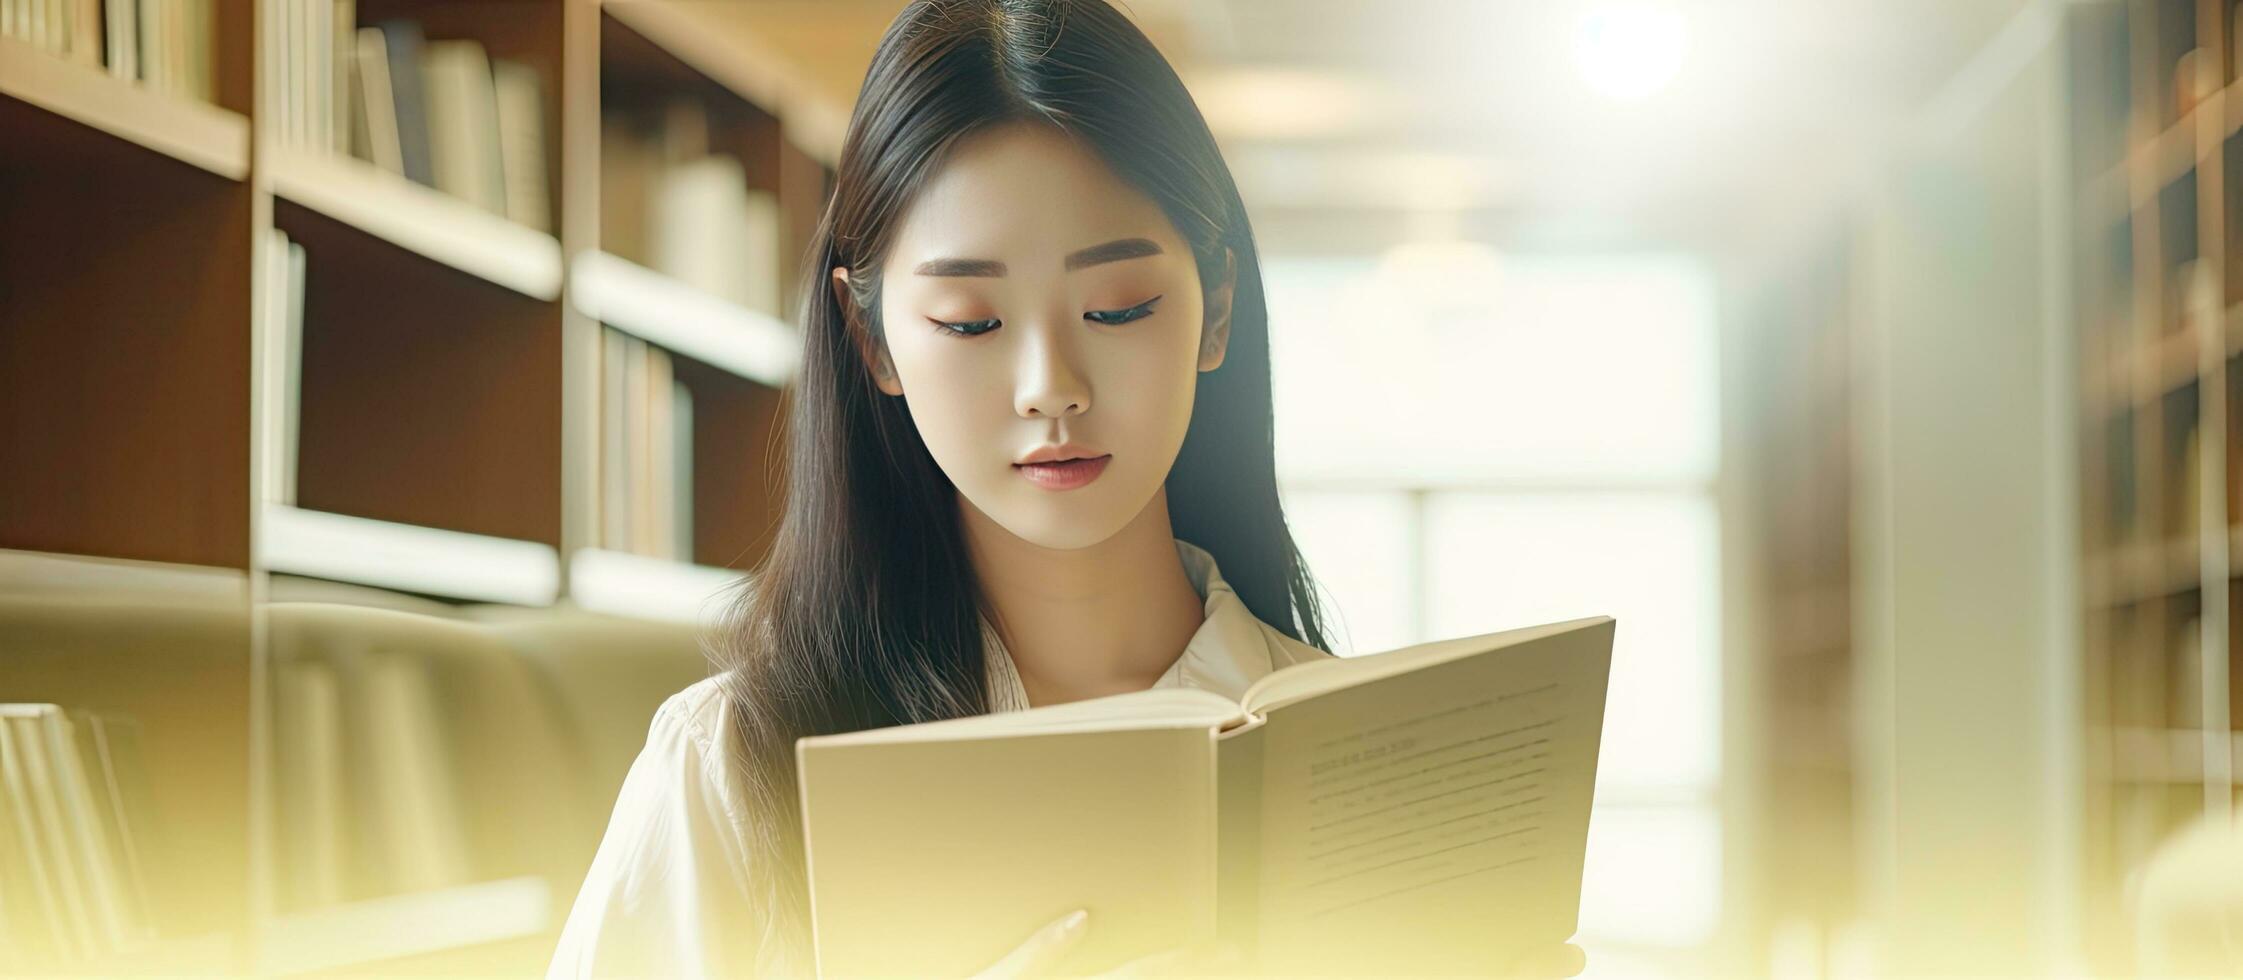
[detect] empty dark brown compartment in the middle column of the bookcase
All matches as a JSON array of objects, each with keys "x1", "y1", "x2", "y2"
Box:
[{"x1": 274, "y1": 200, "x2": 561, "y2": 547}]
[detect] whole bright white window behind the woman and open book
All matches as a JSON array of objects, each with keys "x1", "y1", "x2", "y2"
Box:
[{"x1": 1263, "y1": 247, "x2": 1720, "y2": 959}]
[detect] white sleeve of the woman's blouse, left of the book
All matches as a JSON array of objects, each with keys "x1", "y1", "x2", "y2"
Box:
[{"x1": 545, "y1": 682, "x2": 763, "y2": 980}]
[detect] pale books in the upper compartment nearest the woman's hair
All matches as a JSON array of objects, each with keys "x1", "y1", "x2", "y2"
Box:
[{"x1": 601, "y1": 101, "x2": 781, "y2": 316}]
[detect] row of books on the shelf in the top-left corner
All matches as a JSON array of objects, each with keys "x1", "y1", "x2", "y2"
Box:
[{"x1": 0, "y1": 0, "x2": 218, "y2": 101}]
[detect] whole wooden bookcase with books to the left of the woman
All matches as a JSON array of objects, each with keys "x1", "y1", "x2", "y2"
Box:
[{"x1": 0, "y1": 0, "x2": 846, "y2": 973}]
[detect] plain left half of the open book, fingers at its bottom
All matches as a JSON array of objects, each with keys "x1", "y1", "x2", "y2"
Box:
[{"x1": 796, "y1": 722, "x2": 1236, "y2": 978}]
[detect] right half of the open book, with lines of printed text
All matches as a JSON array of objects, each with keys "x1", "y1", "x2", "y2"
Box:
[{"x1": 1258, "y1": 617, "x2": 1613, "y2": 971}]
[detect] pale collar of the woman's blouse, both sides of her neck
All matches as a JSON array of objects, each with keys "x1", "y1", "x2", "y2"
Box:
[{"x1": 980, "y1": 538, "x2": 1276, "y2": 711}]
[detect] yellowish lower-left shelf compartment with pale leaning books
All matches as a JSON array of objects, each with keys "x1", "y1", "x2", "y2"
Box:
[{"x1": 0, "y1": 549, "x2": 251, "y2": 973}]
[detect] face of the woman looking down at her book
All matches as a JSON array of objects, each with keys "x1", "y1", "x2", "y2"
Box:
[{"x1": 834, "y1": 123, "x2": 1231, "y2": 549}]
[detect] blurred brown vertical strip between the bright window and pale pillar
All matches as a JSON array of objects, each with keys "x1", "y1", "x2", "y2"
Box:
[{"x1": 1736, "y1": 224, "x2": 1866, "y2": 976}]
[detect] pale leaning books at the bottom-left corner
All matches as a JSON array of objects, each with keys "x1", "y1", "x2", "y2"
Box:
[{"x1": 0, "y1": 704, "x2": 155, "y2": 971}]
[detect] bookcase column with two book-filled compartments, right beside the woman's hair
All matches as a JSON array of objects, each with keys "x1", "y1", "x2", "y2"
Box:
[{"x1": 570, "y1": 2, "x2": 837, "y2": 617}]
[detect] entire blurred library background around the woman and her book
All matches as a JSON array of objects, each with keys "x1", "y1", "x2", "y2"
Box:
[{"x1": 0, "y1": 0, "x2": 2243, "y2": 978}]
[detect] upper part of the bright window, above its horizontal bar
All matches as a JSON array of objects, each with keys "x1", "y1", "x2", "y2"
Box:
[{"x1": 1263, "y1": 242, "x2": 1718, "y2": 487}]
